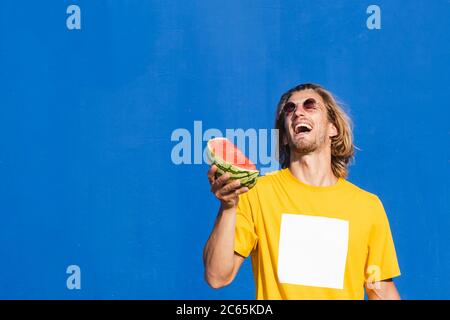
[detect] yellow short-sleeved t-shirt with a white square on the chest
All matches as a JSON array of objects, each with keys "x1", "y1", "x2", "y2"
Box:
[{"x1": 235, "y1": 169, "x2": 400, "y2": 299}]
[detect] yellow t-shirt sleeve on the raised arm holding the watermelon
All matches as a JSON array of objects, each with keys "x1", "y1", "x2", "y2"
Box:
[{"x1": 234, "y1": 189, "x2": 258, "y2": 257}]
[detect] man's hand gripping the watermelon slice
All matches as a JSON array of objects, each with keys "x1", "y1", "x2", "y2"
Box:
[{"x1": 208, "y1": 165, "x2": 248, "y2": 209}]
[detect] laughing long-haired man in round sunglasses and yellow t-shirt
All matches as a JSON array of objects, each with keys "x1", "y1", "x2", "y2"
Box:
[{"x1": 204, "y1": 84, "x2": 400, "y2": 299}]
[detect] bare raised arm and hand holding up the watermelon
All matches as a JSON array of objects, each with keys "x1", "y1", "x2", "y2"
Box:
[{"x1": 203, "y1": 166, "x2": 248, "y2": 289}]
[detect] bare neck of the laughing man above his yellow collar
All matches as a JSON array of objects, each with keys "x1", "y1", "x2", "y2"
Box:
[{"x1": 289, "y1": 150, "x2": 338, "y2": 187}]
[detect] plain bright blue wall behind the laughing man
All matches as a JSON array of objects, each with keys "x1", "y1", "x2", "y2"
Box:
[{"x1": 0, "y1": 0, "x2": 450, "y2": 299}]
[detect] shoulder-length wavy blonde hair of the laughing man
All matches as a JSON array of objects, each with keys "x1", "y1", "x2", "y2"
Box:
[{"x1": 275, "y1": 83, "x2": 355, "y2": 178}]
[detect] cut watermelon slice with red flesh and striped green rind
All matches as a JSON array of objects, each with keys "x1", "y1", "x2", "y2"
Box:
[{"x1": 207, "y1": 138, "x2": 259, "y2": 189}]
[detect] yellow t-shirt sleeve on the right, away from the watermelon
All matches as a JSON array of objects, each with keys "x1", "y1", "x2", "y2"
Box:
[{"x1": 366, "y1": 197, "x2": 400, "y2": 282}]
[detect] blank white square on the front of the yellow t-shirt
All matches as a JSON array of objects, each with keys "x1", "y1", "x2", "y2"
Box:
[{"x1": 278, "y1": 213, "x2": 349, "y2": 289}]
